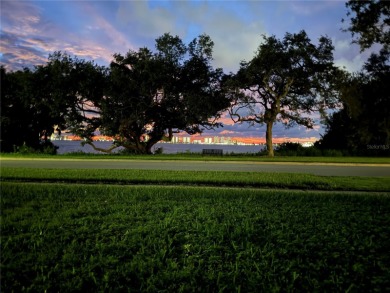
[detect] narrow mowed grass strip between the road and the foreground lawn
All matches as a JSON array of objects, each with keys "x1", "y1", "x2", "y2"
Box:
[{"x1": 1, "y1": 167, "x2": 390, "y2": 192}]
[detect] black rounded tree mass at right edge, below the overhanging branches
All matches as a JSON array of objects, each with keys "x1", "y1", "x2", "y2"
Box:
[{"x1": 320, "y1": 52, "x2": 390, "y2": 156}]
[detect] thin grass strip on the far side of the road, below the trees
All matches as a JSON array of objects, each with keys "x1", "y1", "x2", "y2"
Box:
[{"x1": 0, "y1": 153, "x2": 390, "y2": 164}]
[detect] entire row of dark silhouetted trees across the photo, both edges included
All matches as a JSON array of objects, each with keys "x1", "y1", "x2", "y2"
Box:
[{"x1": 0, "y1": 1, "x2": 390, "y2": 156}]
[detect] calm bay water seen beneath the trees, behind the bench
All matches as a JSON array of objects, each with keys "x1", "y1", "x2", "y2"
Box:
[{"x1": 53, "y1": 140, "x2": 264, "y2": 154}]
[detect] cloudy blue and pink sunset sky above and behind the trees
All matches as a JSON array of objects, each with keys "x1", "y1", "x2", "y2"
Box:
[{"x1": 0, "y1": 0, "x2": 370, "y2": 140}]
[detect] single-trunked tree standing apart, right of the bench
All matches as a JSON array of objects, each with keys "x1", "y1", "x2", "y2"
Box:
[{"x1": 229, "y1": 31, "x2": 337, "y2": 157}]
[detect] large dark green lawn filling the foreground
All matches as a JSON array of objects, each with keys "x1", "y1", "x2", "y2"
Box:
[{"x1": 1, "y1": 182, "x2": 390, "y2": 292}]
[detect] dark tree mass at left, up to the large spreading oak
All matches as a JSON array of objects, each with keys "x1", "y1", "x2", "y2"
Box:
[{"x1": 0, "y1": 52, "x2": 104, "y2": 152}]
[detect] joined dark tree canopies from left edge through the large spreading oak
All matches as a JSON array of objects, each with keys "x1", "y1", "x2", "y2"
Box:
[{"x1": 1, "y1": 34, "x2": 229, "y2": 154}]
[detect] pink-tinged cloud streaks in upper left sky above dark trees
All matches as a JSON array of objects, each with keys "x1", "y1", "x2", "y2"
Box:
[{"x1": 0, "y1": 1, "x2": 132, "y2": 70}]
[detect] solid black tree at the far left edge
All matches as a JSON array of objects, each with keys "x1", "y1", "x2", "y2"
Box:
[{"x1": 0, "y1": 67, "x2": 62, "y2": 152}]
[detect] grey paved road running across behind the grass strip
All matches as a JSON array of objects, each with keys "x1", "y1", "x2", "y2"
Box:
[{"x1": 0, "y1": 158, "x2": 390, "y2": 177}]
